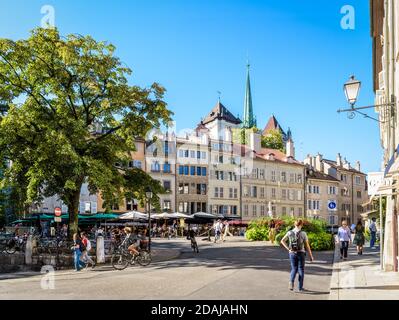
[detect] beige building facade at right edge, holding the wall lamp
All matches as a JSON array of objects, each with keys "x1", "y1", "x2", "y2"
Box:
[{"x1": 370, "y1": 0, "x2": 399, "y2": 271}]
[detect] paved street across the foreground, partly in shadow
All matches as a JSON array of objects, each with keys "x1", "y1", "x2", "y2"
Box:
[{"x1": 0, "y1": 237, "x2": 333, "y2": 300}]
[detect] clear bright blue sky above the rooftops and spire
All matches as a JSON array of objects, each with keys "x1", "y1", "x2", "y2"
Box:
[{"x1": 0, "y1": 0, "x2": 382, "y2": 171}]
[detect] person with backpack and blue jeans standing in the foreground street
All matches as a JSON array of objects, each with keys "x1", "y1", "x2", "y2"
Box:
[{"x1": 281, "y1": 219, "x2": 314, "y2": 292}]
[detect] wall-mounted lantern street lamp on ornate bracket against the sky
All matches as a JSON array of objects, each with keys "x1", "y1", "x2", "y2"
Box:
[{"x1": 337, "y1": 76, "x2": 395, "y2": 123}]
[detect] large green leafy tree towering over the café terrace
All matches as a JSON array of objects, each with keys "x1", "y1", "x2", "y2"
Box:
[{"x1": 0, "y1": 28, "x2": 172, "y2": 232}]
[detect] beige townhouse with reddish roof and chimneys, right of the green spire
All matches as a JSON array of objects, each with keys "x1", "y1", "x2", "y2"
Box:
[{"x1": 242, "y1": 134, "x2": 304, "y2": 221}]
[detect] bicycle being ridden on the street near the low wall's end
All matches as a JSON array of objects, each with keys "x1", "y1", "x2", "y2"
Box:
[{"x1": 111, "y1": 245, "x2": 152, "y2": 270}]
